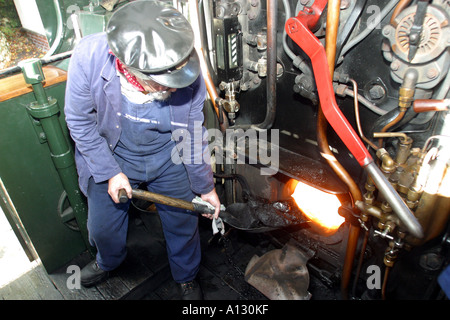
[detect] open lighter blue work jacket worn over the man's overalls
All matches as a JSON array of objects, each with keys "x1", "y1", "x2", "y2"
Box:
[{"x1": 64, "y1": 33, "x2": 214, "y2": 194}]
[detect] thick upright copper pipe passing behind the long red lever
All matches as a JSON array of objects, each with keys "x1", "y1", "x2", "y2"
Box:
[{"x1": 317, "y1": 0, "x2": 362, "y2": 299}]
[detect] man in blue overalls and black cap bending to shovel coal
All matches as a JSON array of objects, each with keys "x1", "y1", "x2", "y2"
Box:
[{"x1": 65, "y1": 0, "x2": 220, "y2": 299}]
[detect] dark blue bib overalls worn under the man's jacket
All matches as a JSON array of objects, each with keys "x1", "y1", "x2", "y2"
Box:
[{"x1": 87, "y1": 96, "x2": 201, "y2": 283}]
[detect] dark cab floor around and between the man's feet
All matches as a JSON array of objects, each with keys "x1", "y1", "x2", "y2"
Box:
[{"x1": 49, "y1": 202, "x2": 336, "y2": 300}]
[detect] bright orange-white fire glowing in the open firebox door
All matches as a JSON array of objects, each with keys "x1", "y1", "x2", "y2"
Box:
[{"x1": 291, "y1": 180, "x2": 345, "y2": 233}]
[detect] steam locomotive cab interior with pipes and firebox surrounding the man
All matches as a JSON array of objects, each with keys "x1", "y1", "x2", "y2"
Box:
[{"x1": 0, "y1": 0, "x2": 450, "y2": 300}]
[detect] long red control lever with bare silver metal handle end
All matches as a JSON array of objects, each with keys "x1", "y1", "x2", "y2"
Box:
[{"x1": 285, "y1": 0, "x2": 423, "y2": 238}]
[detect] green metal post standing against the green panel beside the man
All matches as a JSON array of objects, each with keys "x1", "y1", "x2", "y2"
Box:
[{"x1": 19, "y1": 59, "x2": 95, "y2": 254}]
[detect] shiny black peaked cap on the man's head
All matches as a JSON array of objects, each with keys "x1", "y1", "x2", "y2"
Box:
[{"x1": 106, "y1": 0, "x2": 200, "y2": 88}]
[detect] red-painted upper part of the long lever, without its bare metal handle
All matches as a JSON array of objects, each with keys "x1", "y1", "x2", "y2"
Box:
[{"x1": 285, "y1": 13, "x2": 373, "y2": 167}]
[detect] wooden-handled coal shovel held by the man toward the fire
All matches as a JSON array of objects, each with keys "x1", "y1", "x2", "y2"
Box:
[{"x1": 119, "y1": 189, "x2": 279, "y2": 233}]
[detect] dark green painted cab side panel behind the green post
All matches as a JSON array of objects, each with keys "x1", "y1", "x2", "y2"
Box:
[{"x1": 0, "y1": 83, "x2": 86, "y2": 272}]
